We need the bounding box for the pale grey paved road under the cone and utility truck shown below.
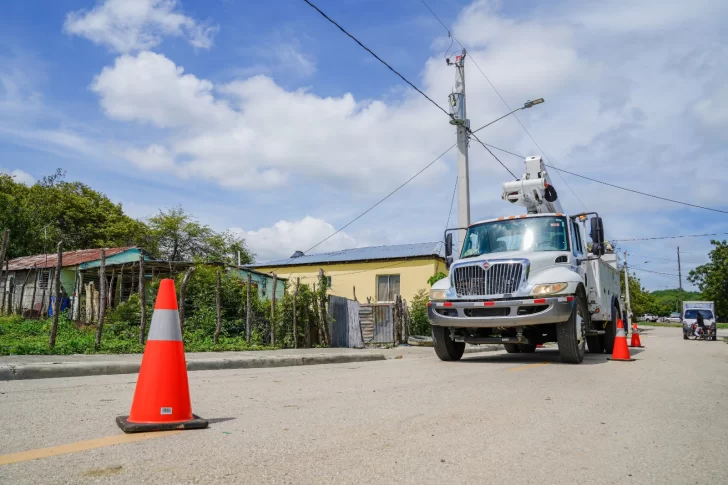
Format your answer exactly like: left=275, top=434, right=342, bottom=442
left=0, top=328, right=728, bottom=484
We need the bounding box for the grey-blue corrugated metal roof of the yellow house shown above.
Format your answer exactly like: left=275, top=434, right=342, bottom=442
left=248, top=241, right=445, bottom=268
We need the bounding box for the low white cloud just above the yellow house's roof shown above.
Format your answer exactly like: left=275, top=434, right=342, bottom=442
left=231, top=216, right=356, bottom=262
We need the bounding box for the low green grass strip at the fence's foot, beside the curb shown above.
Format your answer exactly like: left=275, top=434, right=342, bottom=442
left=0, top=316, right=273, bottom=355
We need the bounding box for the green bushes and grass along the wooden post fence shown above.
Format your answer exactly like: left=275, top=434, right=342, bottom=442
left=0, top=264, right=325, bottom=355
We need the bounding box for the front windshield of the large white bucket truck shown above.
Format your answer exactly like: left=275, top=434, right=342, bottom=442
left=460, top=216, right=569, bottom=258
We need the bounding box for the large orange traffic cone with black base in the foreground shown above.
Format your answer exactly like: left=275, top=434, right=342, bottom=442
left=116, top=279, right=207, bottom=433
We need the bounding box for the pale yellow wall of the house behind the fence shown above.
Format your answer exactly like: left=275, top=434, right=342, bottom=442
left=255, top=258, right=446, bottom=302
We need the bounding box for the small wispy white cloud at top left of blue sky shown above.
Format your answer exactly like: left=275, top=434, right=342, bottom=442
left=63, top=0, right=218, bottom=53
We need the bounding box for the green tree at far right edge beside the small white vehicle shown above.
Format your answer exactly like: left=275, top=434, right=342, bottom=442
left=688, top=240, right=728, bottom=318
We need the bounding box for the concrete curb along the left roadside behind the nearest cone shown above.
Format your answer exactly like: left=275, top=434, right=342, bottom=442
left=0, top=354, right=385, bottom=381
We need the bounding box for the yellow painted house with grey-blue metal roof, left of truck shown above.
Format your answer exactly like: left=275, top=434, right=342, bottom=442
left=249, top=242, right=447, bottom=302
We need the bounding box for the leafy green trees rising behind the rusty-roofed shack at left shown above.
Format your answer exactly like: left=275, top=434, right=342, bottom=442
left=0, top=169, right=252, bottom=263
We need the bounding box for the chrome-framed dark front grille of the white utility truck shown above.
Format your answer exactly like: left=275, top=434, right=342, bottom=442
left=453, top=262, right=523, bottom=297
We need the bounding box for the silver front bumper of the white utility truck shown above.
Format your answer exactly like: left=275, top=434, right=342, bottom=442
left=427, top=296, right=574, bottom=328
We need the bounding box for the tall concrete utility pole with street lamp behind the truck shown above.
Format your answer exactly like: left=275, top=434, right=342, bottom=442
left=447, top=49, right=470, bottom=255
